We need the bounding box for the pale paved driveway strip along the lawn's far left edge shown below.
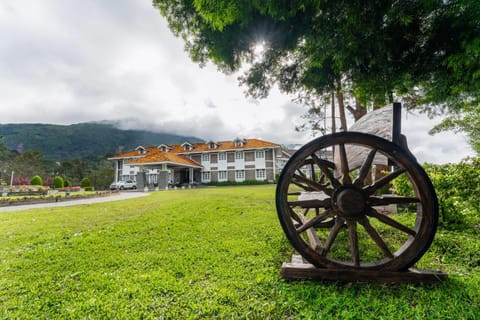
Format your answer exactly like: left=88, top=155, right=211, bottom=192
left=0, top=192, right=149, bottom=212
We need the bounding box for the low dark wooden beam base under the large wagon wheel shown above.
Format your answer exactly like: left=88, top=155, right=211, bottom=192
left=280, top=254, right=447, bottom=283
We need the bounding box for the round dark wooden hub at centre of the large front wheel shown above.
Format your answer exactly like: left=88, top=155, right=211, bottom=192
left=333, top=186, right=367, bottom=218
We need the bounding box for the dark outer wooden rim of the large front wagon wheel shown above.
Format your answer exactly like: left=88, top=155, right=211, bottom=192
left=276, top=132, right=438, bottom=271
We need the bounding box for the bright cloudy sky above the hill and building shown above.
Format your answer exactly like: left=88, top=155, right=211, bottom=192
left=0, top=0, right=473, bottom=163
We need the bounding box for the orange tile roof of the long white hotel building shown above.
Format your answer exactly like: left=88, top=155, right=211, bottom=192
left=109, top=139, right=280, bottom=167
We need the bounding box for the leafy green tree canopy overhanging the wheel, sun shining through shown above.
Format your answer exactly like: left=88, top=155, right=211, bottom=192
left=153, top=0, right=480, bottom=115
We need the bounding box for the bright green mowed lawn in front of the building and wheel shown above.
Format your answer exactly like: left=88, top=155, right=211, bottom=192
left=0, top=186, right=480, bottom=319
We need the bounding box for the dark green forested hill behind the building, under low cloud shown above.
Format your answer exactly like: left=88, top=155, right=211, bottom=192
left=0, top=122, right=203, bottom=161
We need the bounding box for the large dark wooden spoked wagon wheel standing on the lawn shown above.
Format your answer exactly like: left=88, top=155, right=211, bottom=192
left=276, top=132, right=438, bottom=271
